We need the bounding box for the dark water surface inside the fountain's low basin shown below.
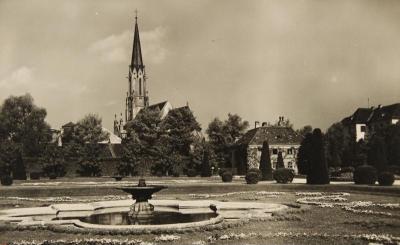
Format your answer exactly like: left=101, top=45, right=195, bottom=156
left=80, top=211, right=217, bottom=225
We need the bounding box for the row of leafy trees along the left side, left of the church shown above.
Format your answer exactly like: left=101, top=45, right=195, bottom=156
left=0, top=94, right=111, bottom=179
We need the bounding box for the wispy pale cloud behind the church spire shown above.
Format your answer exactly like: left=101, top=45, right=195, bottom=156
left=88, top=26, right=168, bottom=64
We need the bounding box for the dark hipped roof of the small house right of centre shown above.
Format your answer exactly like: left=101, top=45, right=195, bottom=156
left=236, top=126, right=303, bottom=145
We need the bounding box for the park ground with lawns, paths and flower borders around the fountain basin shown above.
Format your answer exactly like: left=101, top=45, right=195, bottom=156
left=0, top=177, right=400, bottom=245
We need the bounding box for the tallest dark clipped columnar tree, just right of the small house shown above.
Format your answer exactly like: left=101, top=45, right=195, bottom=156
left=307, top=128, right=329, bottom=185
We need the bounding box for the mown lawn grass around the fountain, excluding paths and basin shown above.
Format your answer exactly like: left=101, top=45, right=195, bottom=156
left=0, top=178, right=400, bottom=244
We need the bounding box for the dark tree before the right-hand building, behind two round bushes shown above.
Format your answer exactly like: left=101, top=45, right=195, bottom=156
left=368, top=135, right=388, bottom=172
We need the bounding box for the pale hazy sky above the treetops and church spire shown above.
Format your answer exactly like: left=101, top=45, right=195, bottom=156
left=0, top=0, right=400, bottom=132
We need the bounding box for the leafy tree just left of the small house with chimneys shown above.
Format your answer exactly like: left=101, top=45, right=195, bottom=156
left=206, top=113, right=249, bottom=168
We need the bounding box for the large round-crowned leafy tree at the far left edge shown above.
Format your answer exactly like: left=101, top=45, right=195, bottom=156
left=0, top=94, right=51, bottom=156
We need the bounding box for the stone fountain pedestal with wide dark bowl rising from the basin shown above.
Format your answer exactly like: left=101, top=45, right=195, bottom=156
left=118, top=179, right=167, bottom=225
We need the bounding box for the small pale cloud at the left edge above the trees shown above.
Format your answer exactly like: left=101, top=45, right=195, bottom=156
left=0, top=66, right=33, bottom=88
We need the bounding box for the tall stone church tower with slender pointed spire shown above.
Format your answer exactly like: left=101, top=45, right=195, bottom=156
left=125, top=15, right=149, bottom=122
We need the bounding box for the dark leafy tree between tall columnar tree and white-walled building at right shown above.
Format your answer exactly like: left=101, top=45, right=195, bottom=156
left=325, top=122, right=352, bottom=167
